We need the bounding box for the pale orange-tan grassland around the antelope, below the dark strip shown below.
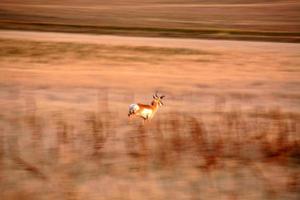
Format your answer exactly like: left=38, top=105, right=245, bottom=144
left=0, top=31, right=300, bottom=200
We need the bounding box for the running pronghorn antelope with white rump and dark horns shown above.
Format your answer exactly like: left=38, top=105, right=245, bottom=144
left=128, top=93, right=165, bottom=121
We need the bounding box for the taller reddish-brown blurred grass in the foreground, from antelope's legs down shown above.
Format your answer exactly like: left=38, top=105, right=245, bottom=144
left=0, top=96, right=300, bottom=199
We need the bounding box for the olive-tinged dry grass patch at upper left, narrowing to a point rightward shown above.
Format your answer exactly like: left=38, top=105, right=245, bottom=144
left=0, top=39, right=217, bottom=63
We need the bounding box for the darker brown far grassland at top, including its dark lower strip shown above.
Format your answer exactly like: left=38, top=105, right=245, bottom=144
left=0, top=0, right=300, bottom=42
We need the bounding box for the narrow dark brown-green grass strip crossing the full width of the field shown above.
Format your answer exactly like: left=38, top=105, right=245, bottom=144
left=0, top=21, right=300, bottom=43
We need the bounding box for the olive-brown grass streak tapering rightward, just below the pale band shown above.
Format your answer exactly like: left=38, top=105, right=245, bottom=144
left=0, top=39, right=213, bottom=59
